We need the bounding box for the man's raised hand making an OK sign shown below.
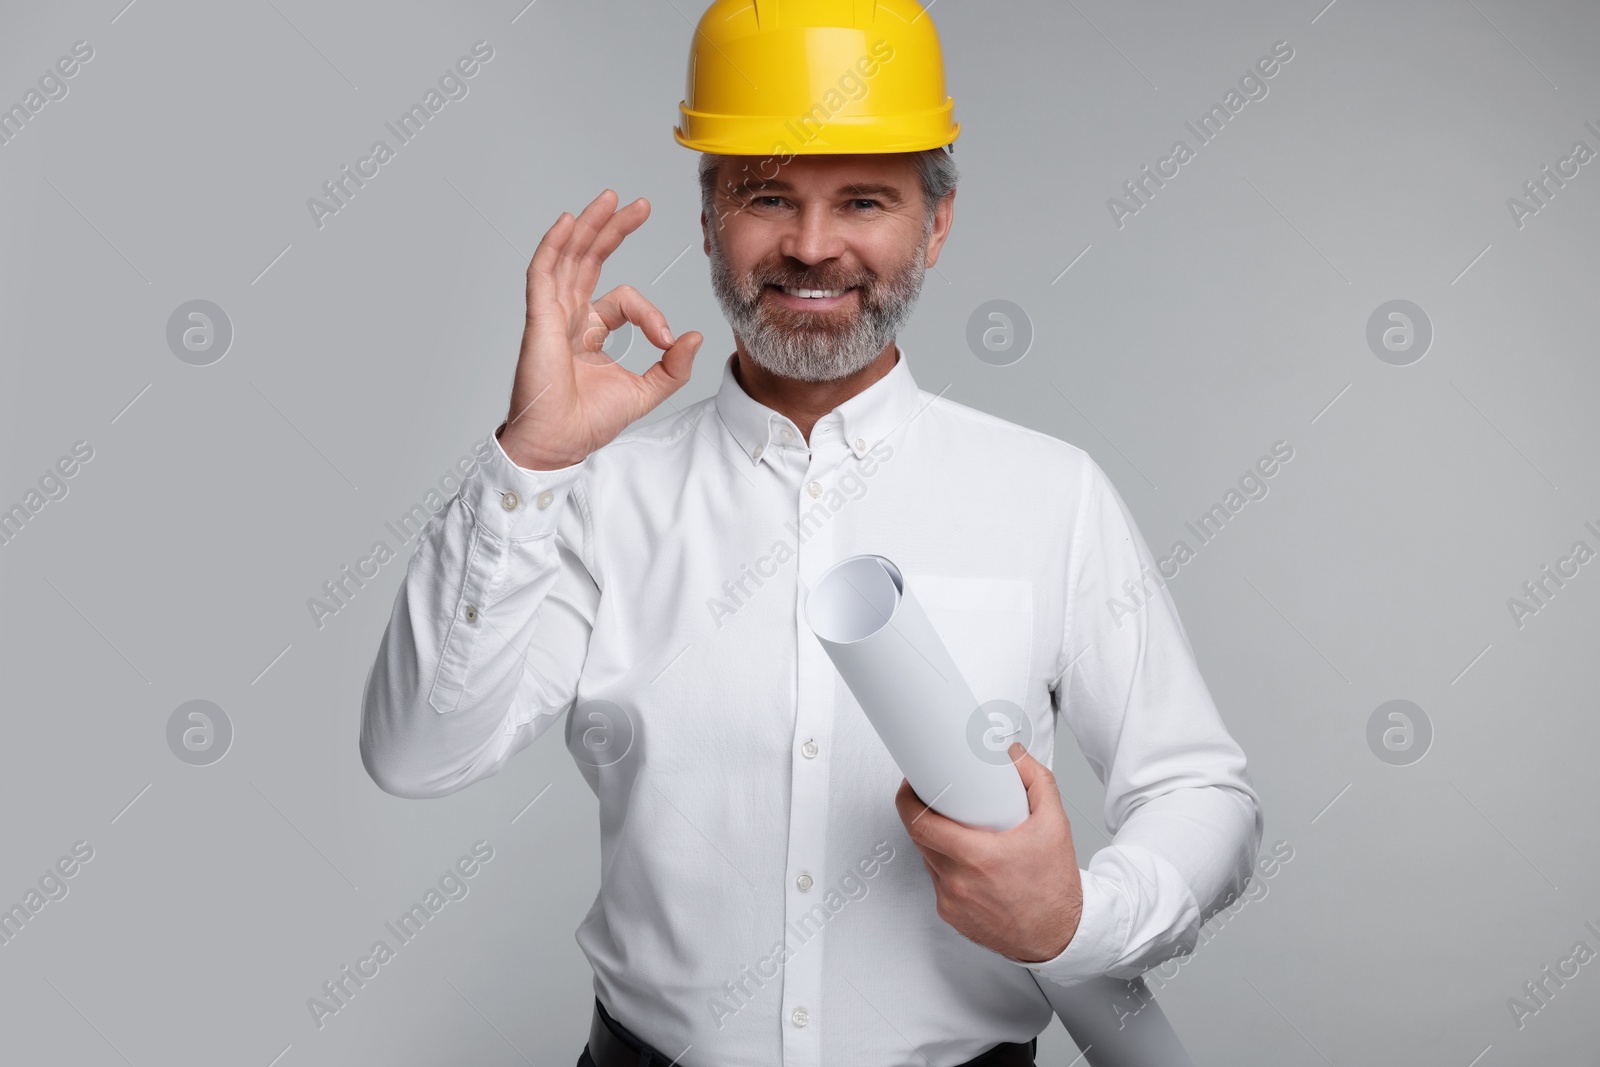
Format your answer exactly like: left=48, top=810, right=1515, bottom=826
left=499, top=189, right=704, bottom=470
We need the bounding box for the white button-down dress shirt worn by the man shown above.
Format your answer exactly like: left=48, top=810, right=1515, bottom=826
left=362, top=347, right=1262, bottom=1067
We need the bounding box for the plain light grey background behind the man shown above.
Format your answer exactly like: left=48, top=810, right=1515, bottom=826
left=0, top=0, right=1600, bottom=1067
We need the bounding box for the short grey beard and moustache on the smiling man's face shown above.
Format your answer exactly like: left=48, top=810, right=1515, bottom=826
left=709, top=219, right=933, bottom=382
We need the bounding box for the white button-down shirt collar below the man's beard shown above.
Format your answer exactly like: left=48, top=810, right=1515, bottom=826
left=717, top=342, right=918, bottom=464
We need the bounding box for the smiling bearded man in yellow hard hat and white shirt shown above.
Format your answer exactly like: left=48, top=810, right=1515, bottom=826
left=362, top=0, right=1262, bottom=1067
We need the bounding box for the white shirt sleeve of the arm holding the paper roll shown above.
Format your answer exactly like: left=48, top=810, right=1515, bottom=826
left=1008, top=456, right=1264, bottom=985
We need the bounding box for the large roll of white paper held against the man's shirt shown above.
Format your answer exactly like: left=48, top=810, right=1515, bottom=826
left=805, top=553, right=1194, bottom=1067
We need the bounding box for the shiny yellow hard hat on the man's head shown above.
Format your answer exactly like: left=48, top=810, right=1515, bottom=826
left=672, top=0, right=962, bottom=155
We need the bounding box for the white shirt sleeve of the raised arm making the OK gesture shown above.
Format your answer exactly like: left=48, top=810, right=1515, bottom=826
left=360, top=425, right=600, bottom=798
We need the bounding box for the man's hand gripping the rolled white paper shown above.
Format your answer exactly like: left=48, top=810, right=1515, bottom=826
left=894, top=741, right=1083, bottom=963
